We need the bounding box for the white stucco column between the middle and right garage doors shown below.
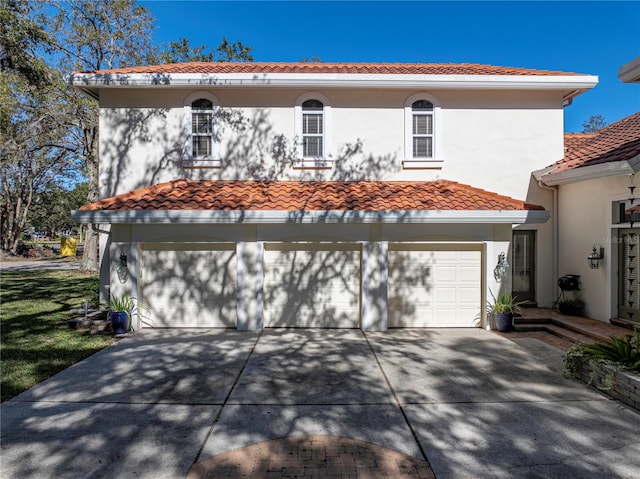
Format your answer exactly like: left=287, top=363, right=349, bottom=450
left=361, top=241, right=389, bottom=331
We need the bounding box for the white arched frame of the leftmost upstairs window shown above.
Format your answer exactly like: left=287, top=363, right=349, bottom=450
left=182, top=91, right=222, bottom=168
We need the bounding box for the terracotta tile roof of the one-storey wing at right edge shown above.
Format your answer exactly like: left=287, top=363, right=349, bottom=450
left=551, top=112, right=640, bottom=173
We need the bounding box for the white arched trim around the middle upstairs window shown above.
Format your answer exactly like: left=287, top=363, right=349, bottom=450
left=293, top=92, right=333, bottom=168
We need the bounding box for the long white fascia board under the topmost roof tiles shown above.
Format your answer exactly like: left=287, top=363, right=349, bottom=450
left=69, top=73, right=598, bottom=92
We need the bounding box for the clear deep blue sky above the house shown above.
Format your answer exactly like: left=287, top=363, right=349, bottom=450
left=140, top=0, right=640, bottom=131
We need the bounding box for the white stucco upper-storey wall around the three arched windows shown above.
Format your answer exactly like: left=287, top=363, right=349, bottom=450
left=100, top=88, right=563, bottom=199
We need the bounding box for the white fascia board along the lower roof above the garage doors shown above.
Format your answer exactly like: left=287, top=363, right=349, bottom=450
left=71, top=210, right=549, bottom=224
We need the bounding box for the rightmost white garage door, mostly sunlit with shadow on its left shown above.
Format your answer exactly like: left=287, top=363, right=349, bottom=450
left=388, top=245, right=482, bottom=327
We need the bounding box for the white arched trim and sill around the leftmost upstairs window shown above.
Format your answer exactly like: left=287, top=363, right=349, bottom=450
left=182, top=91, right=222, bottom=168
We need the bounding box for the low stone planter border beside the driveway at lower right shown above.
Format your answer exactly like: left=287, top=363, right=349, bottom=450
left=574, top=359, right=640, bottom=411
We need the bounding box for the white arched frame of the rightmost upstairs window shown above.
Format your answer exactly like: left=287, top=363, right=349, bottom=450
left=402, top=93, right=444, bottom=169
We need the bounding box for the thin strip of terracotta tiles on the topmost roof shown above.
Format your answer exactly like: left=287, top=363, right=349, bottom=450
left=83, top=62, right=578, bottom=76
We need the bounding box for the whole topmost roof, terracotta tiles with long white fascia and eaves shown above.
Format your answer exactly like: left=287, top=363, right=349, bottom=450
left=69, top=62, right=598, bottom=103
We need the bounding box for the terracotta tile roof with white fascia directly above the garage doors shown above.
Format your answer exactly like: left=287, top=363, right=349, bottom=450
left=73, top=179, right=548, bottom=227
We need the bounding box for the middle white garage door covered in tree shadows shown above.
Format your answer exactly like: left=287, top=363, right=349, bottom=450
left=264, top=243, right=360, bottom=328
